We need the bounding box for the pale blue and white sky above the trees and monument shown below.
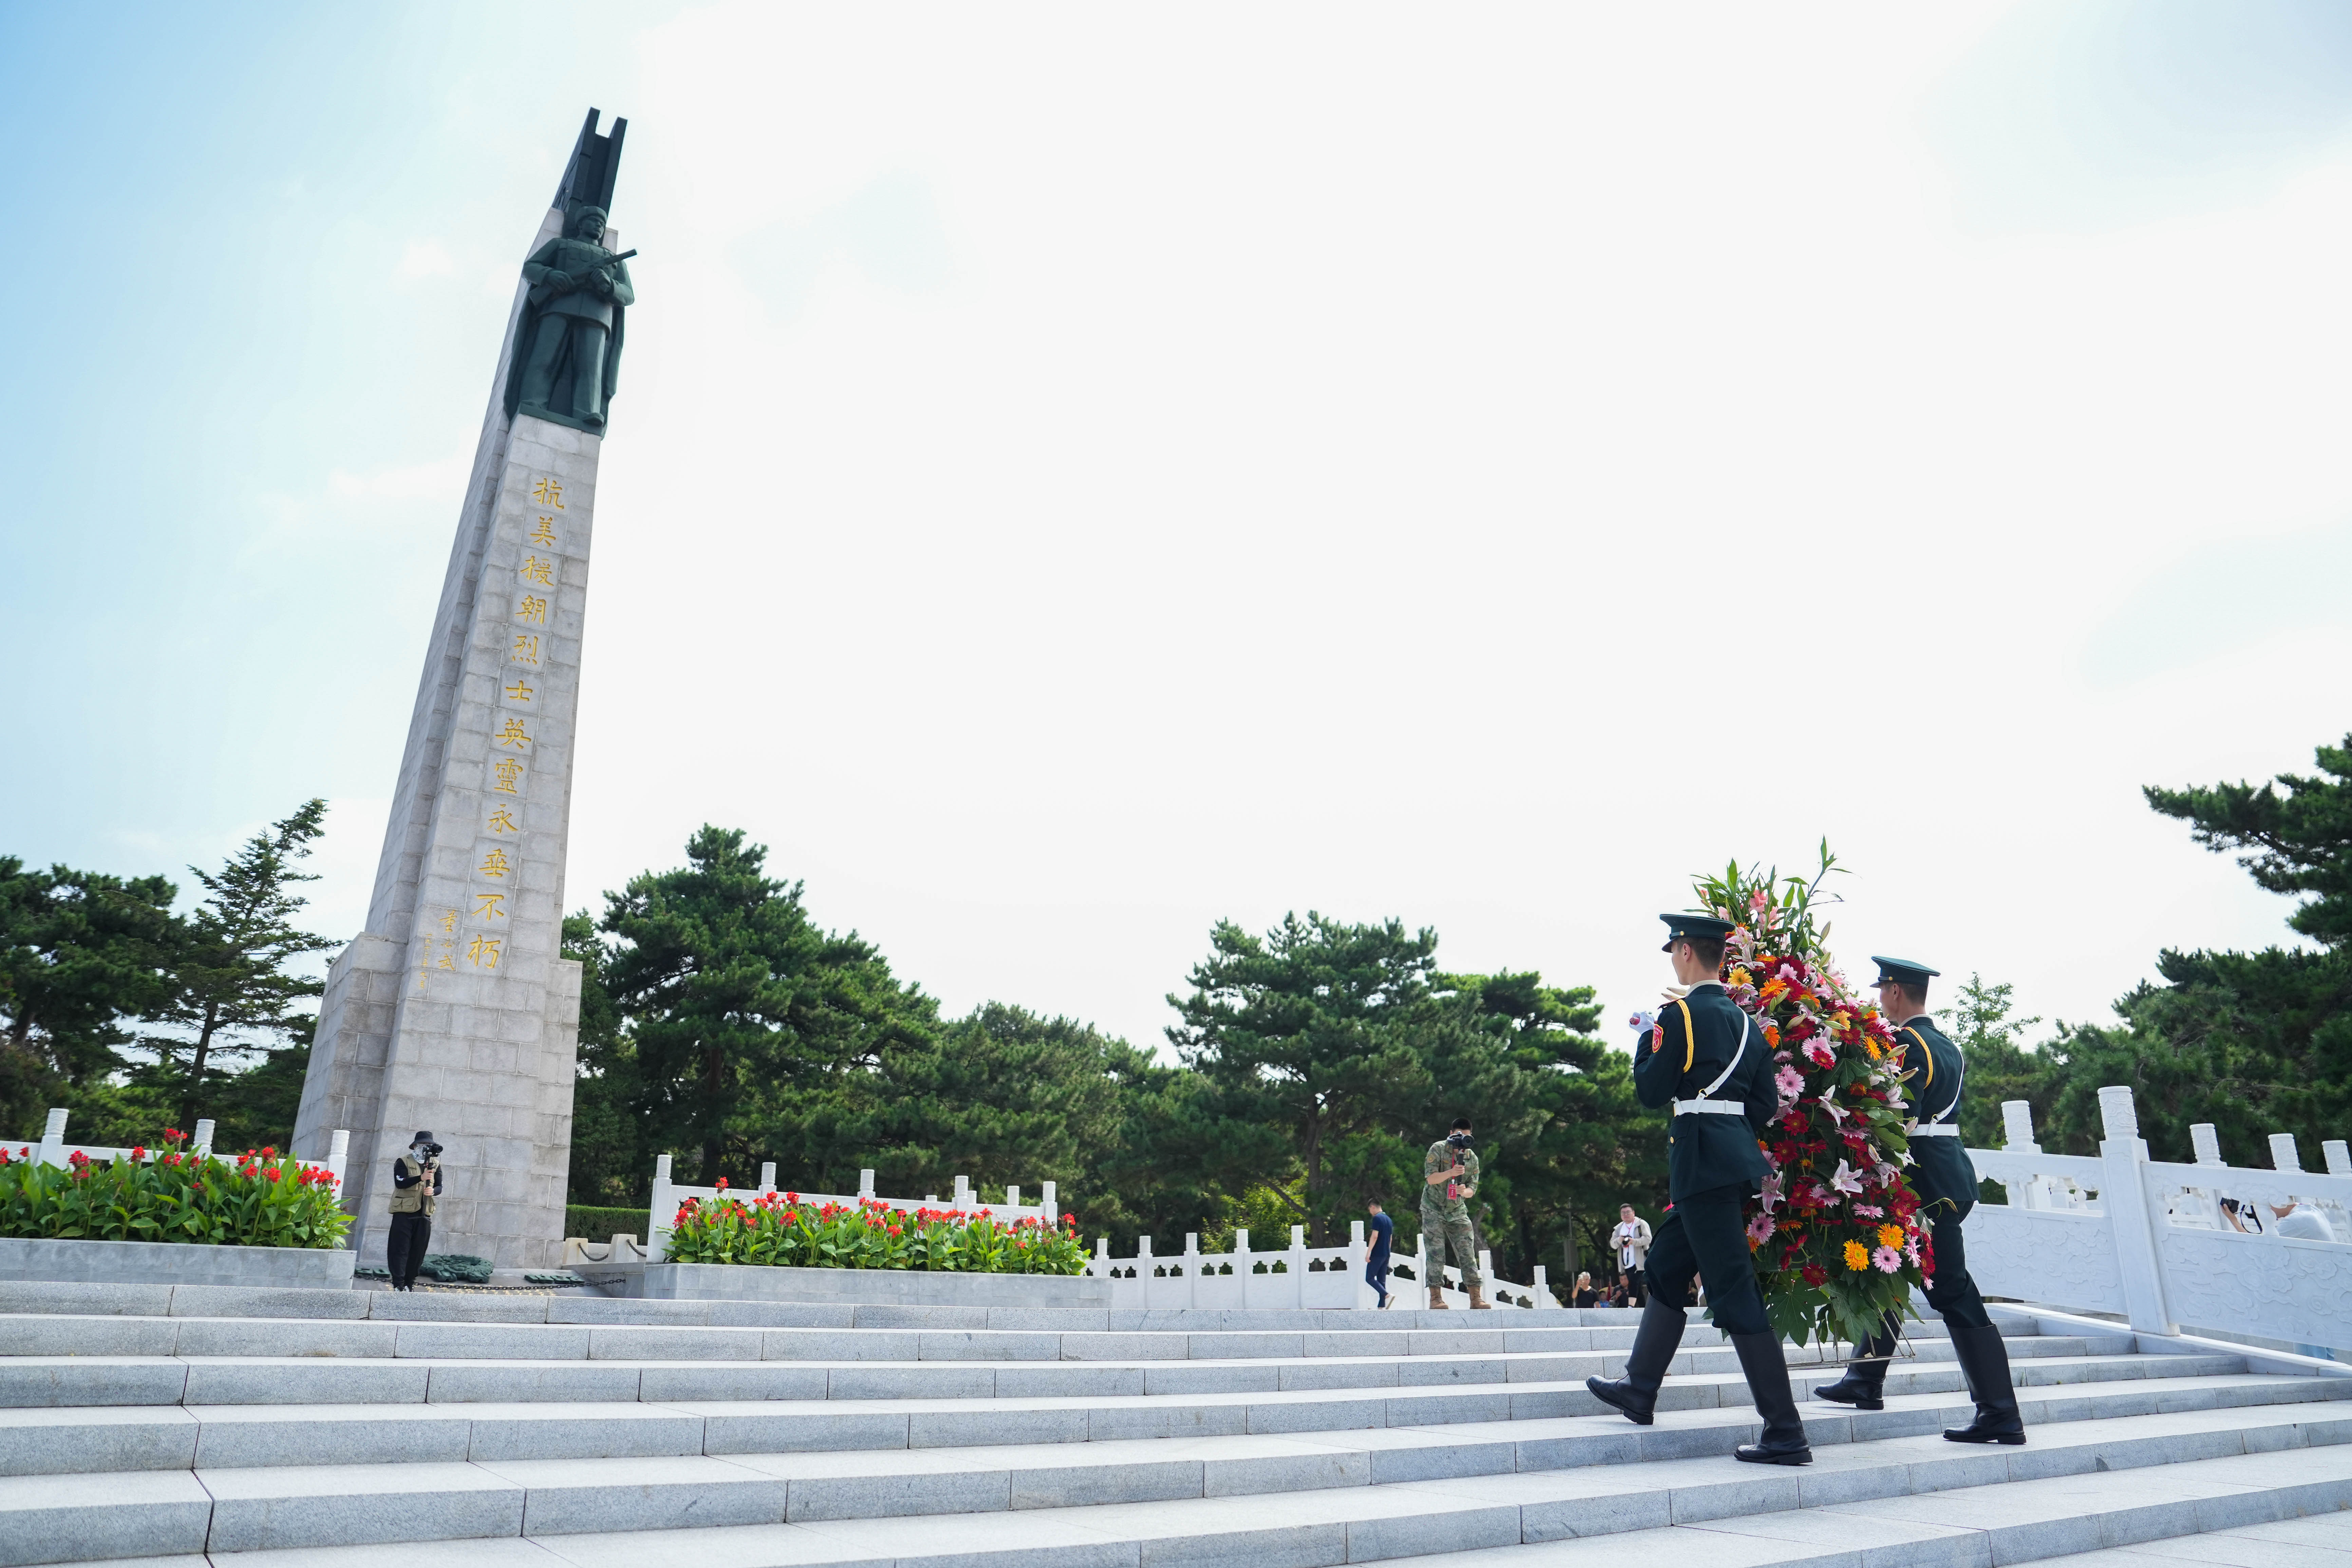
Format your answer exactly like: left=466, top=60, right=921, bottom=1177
left=0, top=0, right=2352, bottom=1072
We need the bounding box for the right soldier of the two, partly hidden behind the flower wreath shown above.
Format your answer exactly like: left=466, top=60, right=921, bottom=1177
left=1813, top=955, right=2025, bottom=1446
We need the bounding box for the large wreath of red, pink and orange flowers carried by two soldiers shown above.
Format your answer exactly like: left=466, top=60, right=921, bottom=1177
left=1696, top=842, right=1936, bottom=1345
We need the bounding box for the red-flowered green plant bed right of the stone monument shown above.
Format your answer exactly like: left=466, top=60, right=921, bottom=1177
left=668, top=1180, right=1087, bottom=1274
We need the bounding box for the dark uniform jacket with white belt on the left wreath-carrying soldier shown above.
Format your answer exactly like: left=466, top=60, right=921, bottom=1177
left=1632, top=985, right=1781, bottom=1204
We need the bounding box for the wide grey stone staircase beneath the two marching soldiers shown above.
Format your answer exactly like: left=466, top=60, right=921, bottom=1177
left=0, top=1284, right=2352, bottom=1568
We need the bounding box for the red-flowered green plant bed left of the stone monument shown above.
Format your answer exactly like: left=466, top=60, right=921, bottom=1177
left=0, top=1131, right=351, bottom=1248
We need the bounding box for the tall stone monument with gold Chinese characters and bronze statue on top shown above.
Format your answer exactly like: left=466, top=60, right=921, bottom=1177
left=294, top=111, right=635, bottom=1267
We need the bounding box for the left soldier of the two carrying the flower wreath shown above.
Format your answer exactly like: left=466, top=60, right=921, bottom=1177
left=1585, top=914, right=1813, bottom=1465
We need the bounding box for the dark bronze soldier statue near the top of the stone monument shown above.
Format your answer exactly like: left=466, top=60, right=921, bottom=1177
left=506, top=207, right=637, bottom=435
